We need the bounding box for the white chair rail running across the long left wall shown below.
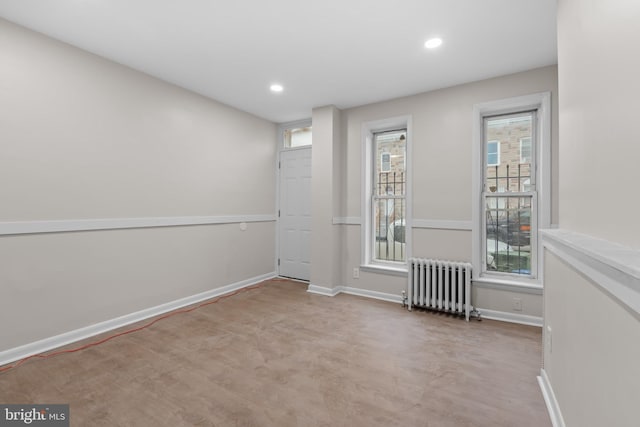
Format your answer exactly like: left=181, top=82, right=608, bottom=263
left=0, top=215, right=276, bottom=236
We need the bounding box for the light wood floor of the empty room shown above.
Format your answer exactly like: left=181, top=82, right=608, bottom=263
left=0, top=280, right=551, bottom=427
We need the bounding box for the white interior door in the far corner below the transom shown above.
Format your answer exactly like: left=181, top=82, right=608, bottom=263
left=278, top=148, right=311, bottom=280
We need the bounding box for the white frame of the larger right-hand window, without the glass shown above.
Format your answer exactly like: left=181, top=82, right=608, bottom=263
left=471, top=92, right=551, bottom=290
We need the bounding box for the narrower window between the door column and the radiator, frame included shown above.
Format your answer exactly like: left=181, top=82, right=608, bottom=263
left=360, top=116, right=411, bottom=275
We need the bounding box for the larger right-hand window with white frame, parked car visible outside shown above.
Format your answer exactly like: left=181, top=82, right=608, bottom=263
left=472, top=92, right=551, bottom=289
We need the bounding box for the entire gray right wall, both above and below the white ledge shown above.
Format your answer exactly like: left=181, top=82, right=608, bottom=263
left=544, top=0, right=640, bottom=427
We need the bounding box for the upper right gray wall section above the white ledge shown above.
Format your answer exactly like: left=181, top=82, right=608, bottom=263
left=558, top=0, right=640, bottom=249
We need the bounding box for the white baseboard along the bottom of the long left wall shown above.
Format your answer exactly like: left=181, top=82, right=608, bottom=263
left=0, top=272, right=277, bottom=366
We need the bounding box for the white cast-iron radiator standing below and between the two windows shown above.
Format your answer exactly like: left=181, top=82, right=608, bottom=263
left=407, top=258, right=473, bottom=321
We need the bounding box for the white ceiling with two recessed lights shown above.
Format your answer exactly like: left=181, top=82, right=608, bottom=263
left=0, top=0, right=557, bottom=122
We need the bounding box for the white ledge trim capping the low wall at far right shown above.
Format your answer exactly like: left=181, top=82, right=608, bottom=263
left=542, top=229, right=640, bottom=317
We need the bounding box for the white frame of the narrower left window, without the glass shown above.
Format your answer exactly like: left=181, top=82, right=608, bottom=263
left=360, top=116, right=413, bottom=276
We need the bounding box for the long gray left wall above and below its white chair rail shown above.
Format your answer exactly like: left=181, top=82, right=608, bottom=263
left=0, top=19, right=276, bottom=351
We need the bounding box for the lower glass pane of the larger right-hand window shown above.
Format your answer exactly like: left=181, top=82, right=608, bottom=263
left=485, top=196, right=532, bottom=275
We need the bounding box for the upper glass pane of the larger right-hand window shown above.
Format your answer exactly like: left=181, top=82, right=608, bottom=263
left=485, top=112, right=534, bottom=193
